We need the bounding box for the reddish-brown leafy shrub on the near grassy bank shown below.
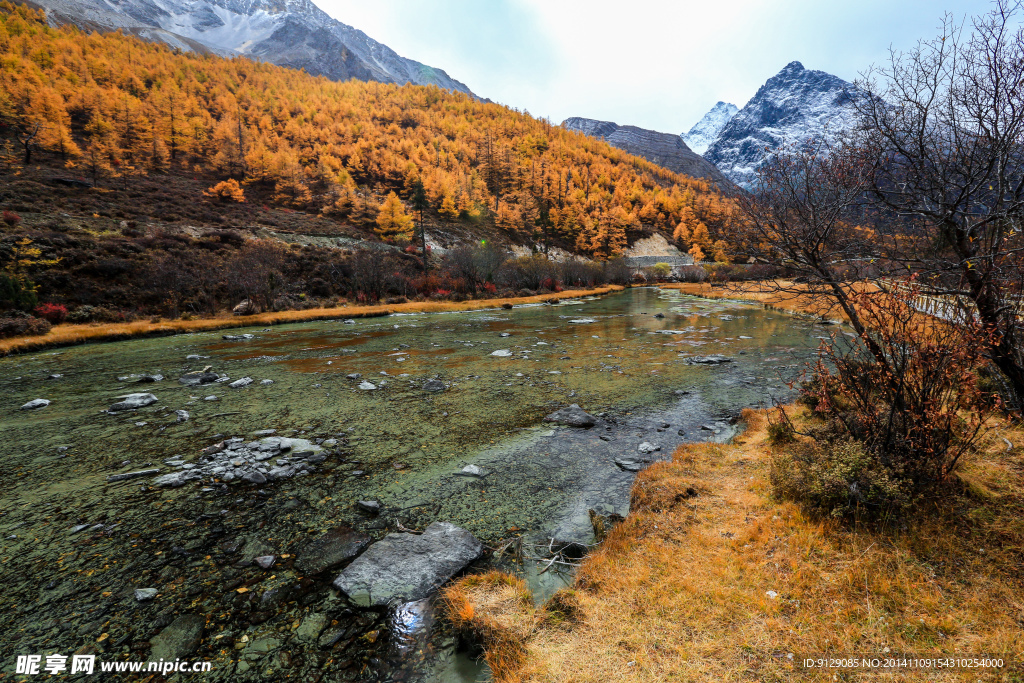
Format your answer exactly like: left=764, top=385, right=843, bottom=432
left=781, top=288, right=990, bottom=514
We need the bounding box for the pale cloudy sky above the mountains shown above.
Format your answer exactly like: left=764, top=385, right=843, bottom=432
left=315, top=0, right=991, bottom=133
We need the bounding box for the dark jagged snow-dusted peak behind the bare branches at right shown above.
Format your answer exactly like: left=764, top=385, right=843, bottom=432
left=703, top=61, right=863, bottom=188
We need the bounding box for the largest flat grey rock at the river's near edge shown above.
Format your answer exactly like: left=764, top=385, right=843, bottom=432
left=334, top=522, right=483, bottom=607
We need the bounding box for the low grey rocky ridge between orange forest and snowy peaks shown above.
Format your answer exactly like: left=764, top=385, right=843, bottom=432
left=562, top=117, right=736, bottom=194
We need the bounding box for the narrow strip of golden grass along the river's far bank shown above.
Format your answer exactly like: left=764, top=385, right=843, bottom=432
left=0, top=285, right=625, bottom=355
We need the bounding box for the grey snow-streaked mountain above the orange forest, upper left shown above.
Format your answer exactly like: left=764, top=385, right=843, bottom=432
left=33, top=0, right=472, bottom=94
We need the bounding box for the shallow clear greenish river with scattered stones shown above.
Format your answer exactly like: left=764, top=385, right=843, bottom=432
left=0, top=289, right=828, bottom=681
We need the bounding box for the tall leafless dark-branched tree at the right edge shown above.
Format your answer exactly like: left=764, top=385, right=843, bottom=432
left=855, top=0, right=1024, bottom=396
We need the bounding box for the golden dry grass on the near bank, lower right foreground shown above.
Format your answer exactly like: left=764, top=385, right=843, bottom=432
left=454, top=409, right=1024, bottom=683
